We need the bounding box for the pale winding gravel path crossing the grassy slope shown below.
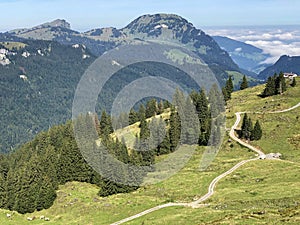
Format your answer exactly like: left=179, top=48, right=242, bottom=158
left=111, top=102, right=300, bottom=225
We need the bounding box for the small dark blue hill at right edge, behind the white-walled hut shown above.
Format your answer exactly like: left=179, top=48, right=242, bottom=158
left=258, top=55, right=300, bottom=79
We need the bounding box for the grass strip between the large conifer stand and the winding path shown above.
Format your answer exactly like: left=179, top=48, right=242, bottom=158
left=0, top=140, right=253, bottom=224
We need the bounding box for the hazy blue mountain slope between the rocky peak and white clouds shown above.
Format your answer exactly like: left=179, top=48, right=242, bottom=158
left=213, top=36, right=270, bottom=74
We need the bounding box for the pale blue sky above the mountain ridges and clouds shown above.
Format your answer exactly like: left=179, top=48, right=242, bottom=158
left=0, top=0, right=300, bottom=32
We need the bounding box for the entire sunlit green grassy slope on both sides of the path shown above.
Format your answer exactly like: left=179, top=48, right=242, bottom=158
left=0, top=79, right=300, bottom=224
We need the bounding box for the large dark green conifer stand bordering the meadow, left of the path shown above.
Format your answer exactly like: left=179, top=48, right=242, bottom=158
left=0, top=85, right=224, bottom=213
